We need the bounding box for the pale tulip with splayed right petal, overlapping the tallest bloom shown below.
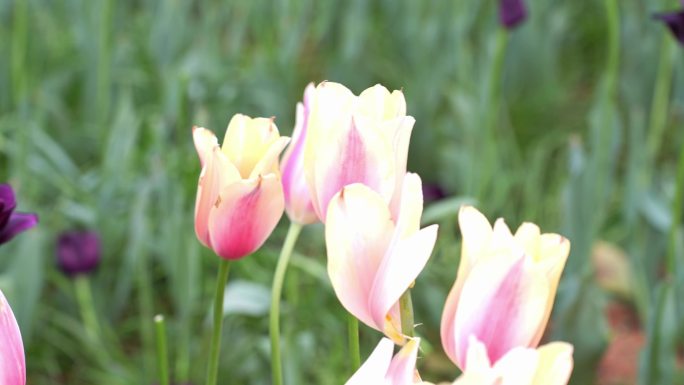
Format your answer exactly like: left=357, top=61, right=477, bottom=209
left=325, top=173, right=437, bottom=344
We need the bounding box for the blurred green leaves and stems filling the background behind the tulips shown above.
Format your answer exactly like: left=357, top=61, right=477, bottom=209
left=0, top=0, right=684, bottom=385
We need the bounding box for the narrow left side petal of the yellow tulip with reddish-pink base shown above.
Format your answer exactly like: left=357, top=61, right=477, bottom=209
left=195, top=146, right=240, bottom=247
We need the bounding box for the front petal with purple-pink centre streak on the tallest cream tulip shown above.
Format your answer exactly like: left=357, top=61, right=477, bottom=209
left=312, top=116, right=395, bottom=219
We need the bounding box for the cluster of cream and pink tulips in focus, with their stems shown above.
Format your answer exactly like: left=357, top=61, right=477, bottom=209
left=193, top=82, right=573, bottom=385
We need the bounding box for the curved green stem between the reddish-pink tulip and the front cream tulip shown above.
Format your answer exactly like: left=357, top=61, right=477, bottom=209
left=269, top=222, right=302, bottom=385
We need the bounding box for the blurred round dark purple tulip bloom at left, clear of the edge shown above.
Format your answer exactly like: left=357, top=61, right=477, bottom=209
left=57, top=231, right=100, bottom=276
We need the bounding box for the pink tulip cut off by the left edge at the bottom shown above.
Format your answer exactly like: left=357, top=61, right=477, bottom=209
left=0, top=291, right=26, bottom=385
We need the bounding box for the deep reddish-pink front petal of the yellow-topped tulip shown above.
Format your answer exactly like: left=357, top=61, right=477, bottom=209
left=209, top=174, right=285, bottom=259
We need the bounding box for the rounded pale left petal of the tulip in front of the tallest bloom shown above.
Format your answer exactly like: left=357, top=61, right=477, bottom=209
left=325, top=184, right=394, bottom=330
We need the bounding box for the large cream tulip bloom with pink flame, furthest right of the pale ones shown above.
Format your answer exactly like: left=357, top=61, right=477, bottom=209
left=441, top=206, right=570, bottom=369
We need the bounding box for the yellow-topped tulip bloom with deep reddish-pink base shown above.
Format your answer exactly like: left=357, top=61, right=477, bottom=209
left=193, top=114, right=289, bottom=259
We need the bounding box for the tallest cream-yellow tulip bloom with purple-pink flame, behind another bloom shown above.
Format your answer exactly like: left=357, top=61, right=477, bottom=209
left=304, top=82, right=415, bottom=222
